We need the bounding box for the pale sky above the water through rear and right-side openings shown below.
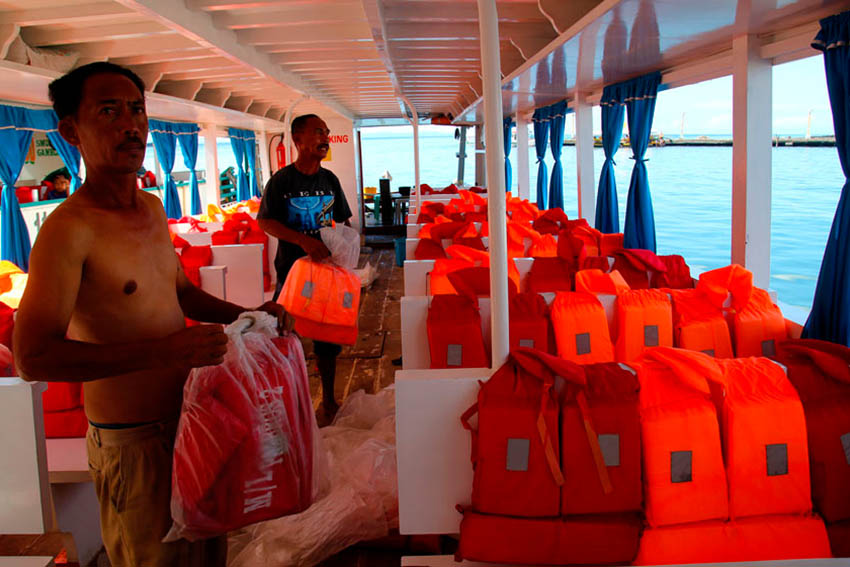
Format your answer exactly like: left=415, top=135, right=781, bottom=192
left=364, top=54, right=833, bottom=138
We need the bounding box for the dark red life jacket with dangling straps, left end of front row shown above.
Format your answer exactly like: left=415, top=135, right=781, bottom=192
left=458, top=348, right=641, bottom=565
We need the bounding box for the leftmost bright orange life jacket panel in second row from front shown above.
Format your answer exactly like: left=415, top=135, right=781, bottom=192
left=552, top=291, right=614, bottom=364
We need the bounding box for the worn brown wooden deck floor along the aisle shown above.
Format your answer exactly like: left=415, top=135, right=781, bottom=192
left=0, top=248, right=438, bottom=567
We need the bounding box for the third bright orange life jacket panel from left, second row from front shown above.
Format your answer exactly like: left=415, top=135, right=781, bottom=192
left=670, top=289, right=735, bottom=358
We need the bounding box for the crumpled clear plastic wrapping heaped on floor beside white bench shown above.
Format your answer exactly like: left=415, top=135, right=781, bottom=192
left=228, top=388, right=398, bottom=567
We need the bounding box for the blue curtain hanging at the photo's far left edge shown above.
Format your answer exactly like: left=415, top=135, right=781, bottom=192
left=0, top=106, right=32, bottom=272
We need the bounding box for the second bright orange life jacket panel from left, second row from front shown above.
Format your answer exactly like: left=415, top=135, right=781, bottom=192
left=615, top=289, right=673, bottom=362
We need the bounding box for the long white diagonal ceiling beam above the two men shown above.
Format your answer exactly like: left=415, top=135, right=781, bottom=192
left=116, top=0, right=354, bottom=118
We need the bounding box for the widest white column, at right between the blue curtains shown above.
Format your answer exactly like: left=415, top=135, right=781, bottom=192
left=732, top=35, right=773, bottom=289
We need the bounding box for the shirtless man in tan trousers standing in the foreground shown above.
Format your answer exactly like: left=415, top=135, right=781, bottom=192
left=14, top=63, right=281, bottom=567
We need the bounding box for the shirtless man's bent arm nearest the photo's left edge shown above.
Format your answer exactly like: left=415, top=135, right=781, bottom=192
left=14, top=210, right=227, bottom=382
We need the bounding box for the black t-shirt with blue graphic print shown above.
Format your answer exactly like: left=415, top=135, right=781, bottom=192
left=257, top=164, right=351, bottom=282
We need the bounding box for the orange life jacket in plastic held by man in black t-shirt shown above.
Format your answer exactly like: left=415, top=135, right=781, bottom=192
left=278, top=257, right=360, bottom=345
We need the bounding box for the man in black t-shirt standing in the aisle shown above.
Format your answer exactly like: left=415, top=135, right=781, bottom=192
left=257, top=114, right=351, bottom=417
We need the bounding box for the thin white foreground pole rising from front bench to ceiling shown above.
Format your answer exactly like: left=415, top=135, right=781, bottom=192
left=478, top=0, right=510, bottom=368
